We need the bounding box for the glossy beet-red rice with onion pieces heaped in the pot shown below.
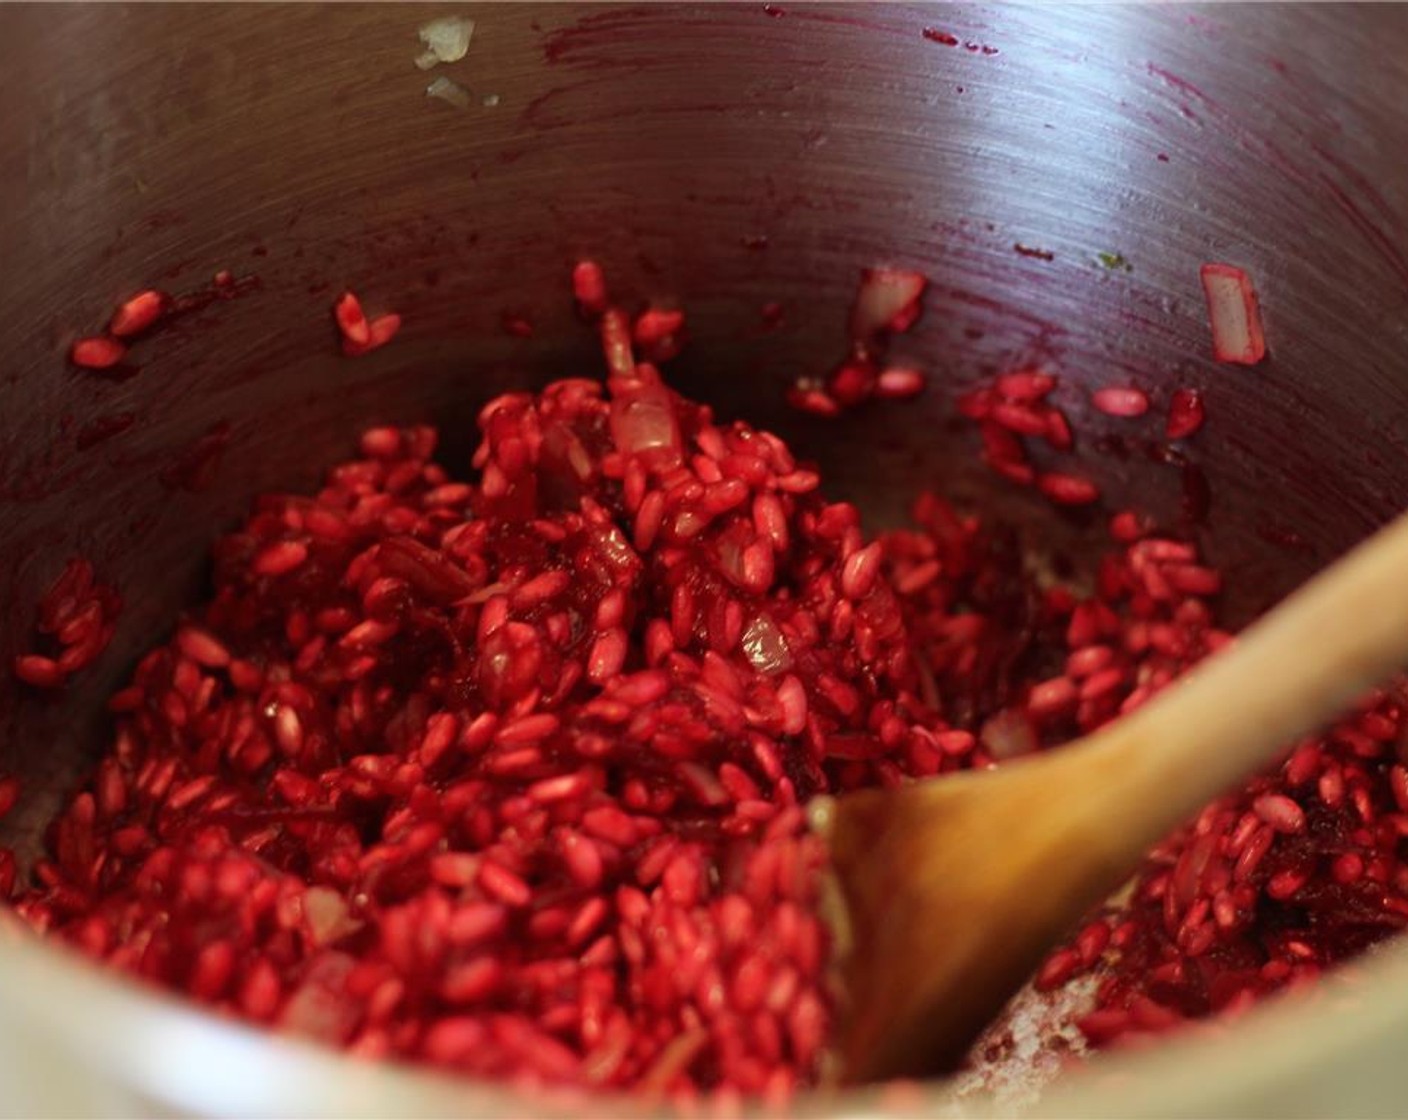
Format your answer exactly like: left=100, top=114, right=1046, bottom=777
left=0, top=263, right=1408, bottom=1097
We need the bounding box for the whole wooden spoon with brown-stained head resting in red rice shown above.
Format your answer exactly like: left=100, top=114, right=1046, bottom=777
left=811, top=514, right=1408, bottom=1082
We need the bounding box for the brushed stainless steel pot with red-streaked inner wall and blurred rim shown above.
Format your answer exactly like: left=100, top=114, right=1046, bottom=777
left=0, top=0, right=1408, bottom=1116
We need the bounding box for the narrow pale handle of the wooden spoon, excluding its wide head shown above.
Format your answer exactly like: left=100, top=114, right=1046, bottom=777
left=1070, top=514, right=1408, bottom=845
